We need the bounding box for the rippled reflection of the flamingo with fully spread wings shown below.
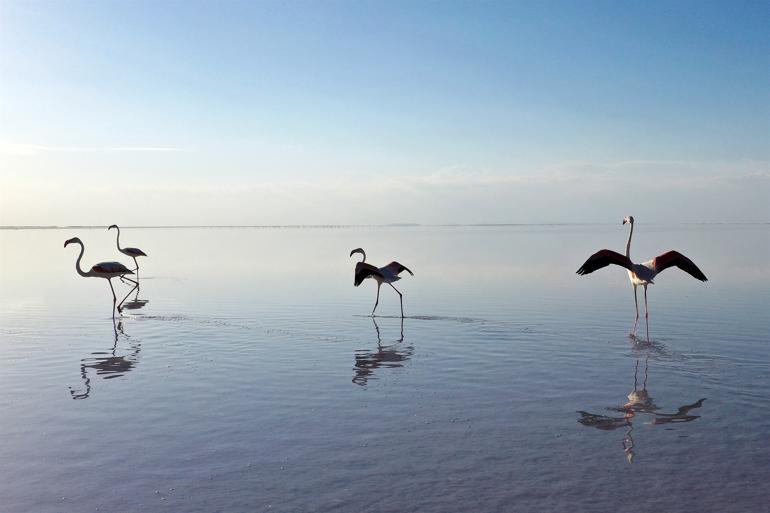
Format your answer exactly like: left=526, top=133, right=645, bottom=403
left=577, top=343, right=706, bottom=463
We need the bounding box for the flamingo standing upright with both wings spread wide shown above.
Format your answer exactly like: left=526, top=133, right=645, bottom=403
left=577, top=216, right=708, bottom=342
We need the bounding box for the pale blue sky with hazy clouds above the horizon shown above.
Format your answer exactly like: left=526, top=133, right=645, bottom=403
left=0, top=0, right=770, bottom=225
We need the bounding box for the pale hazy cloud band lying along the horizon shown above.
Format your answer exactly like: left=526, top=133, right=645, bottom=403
left=0, top=161, right=770, bottom=224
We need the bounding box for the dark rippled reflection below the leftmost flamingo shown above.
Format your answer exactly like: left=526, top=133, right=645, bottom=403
left=70, top=320, right=142, bottom=399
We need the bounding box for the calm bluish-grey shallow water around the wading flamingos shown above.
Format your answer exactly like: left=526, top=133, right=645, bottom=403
left=0, top=222, right=770, bottom=513
